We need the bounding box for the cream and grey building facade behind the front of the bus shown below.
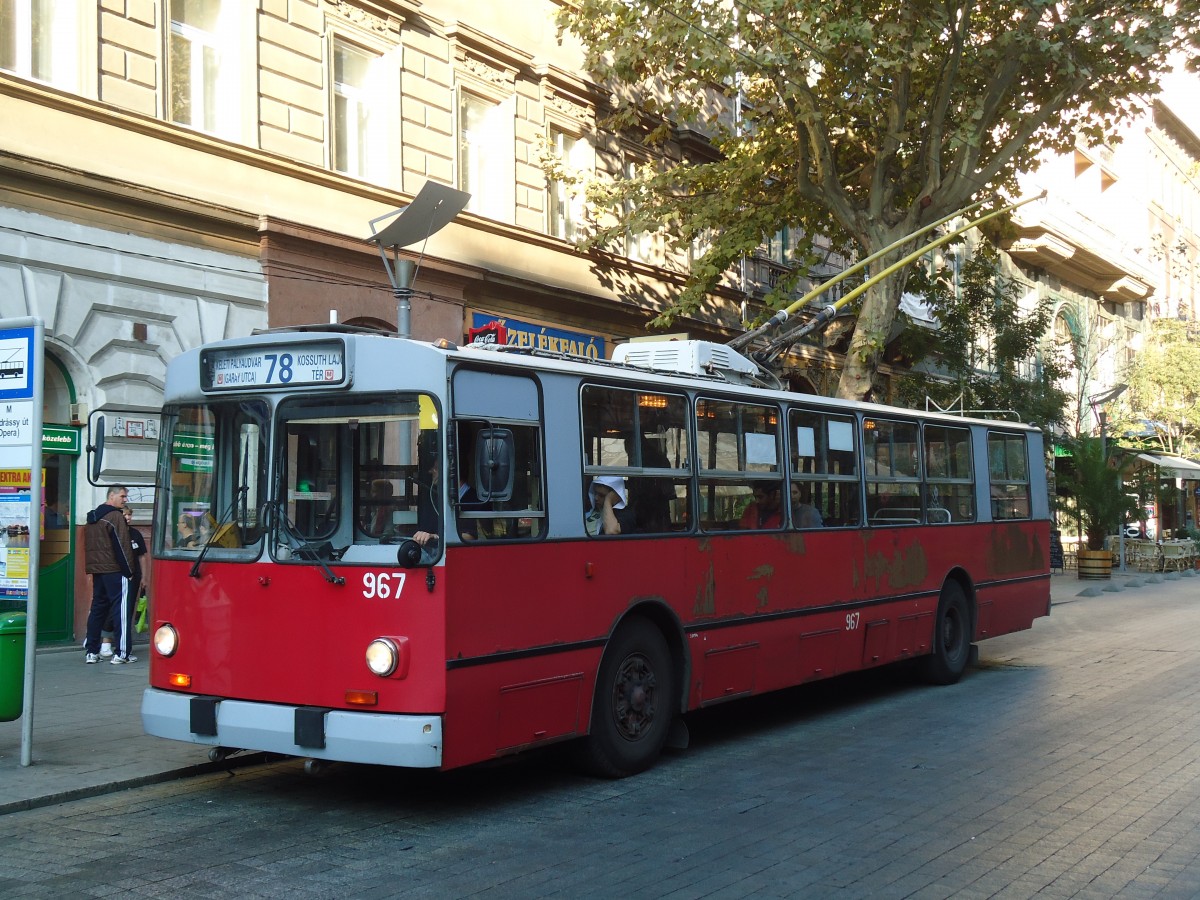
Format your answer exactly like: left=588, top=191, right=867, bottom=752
left=0, top=0, right=738, bottom=640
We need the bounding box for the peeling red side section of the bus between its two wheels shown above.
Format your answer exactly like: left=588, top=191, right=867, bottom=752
left=689, top=529, right=941, bottom=707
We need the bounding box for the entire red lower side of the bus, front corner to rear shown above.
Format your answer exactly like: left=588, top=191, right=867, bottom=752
left=444, top=522, right=1049, bottom=766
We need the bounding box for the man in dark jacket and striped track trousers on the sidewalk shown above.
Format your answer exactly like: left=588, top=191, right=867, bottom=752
left=83, top=485, right=137, bottom=666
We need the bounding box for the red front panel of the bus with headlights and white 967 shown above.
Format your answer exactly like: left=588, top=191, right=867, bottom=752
left=150, top=559, right=445, bottom=713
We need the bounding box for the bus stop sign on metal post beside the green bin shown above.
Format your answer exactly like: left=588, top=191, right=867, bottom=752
left=0, top=318, right=46, bottom=766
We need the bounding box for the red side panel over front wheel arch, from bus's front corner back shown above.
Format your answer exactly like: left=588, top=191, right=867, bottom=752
left=443, top=539, right=688, bottom=768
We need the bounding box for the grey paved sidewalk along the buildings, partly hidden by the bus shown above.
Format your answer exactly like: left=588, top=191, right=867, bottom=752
left=0, top=570, right=1200, bottom=815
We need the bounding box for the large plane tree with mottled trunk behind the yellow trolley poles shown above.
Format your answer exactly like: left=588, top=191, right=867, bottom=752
left=558, top=0, right=1200, bottom=398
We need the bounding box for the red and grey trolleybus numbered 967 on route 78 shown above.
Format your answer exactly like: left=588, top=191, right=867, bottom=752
left=142, top=326, right=1050, bottom=776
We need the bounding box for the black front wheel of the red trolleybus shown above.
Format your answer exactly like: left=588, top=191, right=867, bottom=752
left=580, top=619, right=677, bottom=778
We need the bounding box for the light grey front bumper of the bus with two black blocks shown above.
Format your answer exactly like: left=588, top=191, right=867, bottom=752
left=142, top=688, right=442, bottom=769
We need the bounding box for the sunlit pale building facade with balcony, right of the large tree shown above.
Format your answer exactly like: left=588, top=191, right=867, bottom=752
left=1007, top=64, right=1200, bottom=542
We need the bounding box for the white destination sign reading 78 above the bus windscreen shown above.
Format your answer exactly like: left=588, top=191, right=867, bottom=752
left=200, top=341, right=346, bottom=391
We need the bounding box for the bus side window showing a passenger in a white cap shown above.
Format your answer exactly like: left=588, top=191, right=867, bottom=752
left=581, top=385, right=691, bottom=536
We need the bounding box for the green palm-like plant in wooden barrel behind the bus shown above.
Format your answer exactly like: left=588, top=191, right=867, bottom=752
left=1058, top=437, right=1142, bottom=578
